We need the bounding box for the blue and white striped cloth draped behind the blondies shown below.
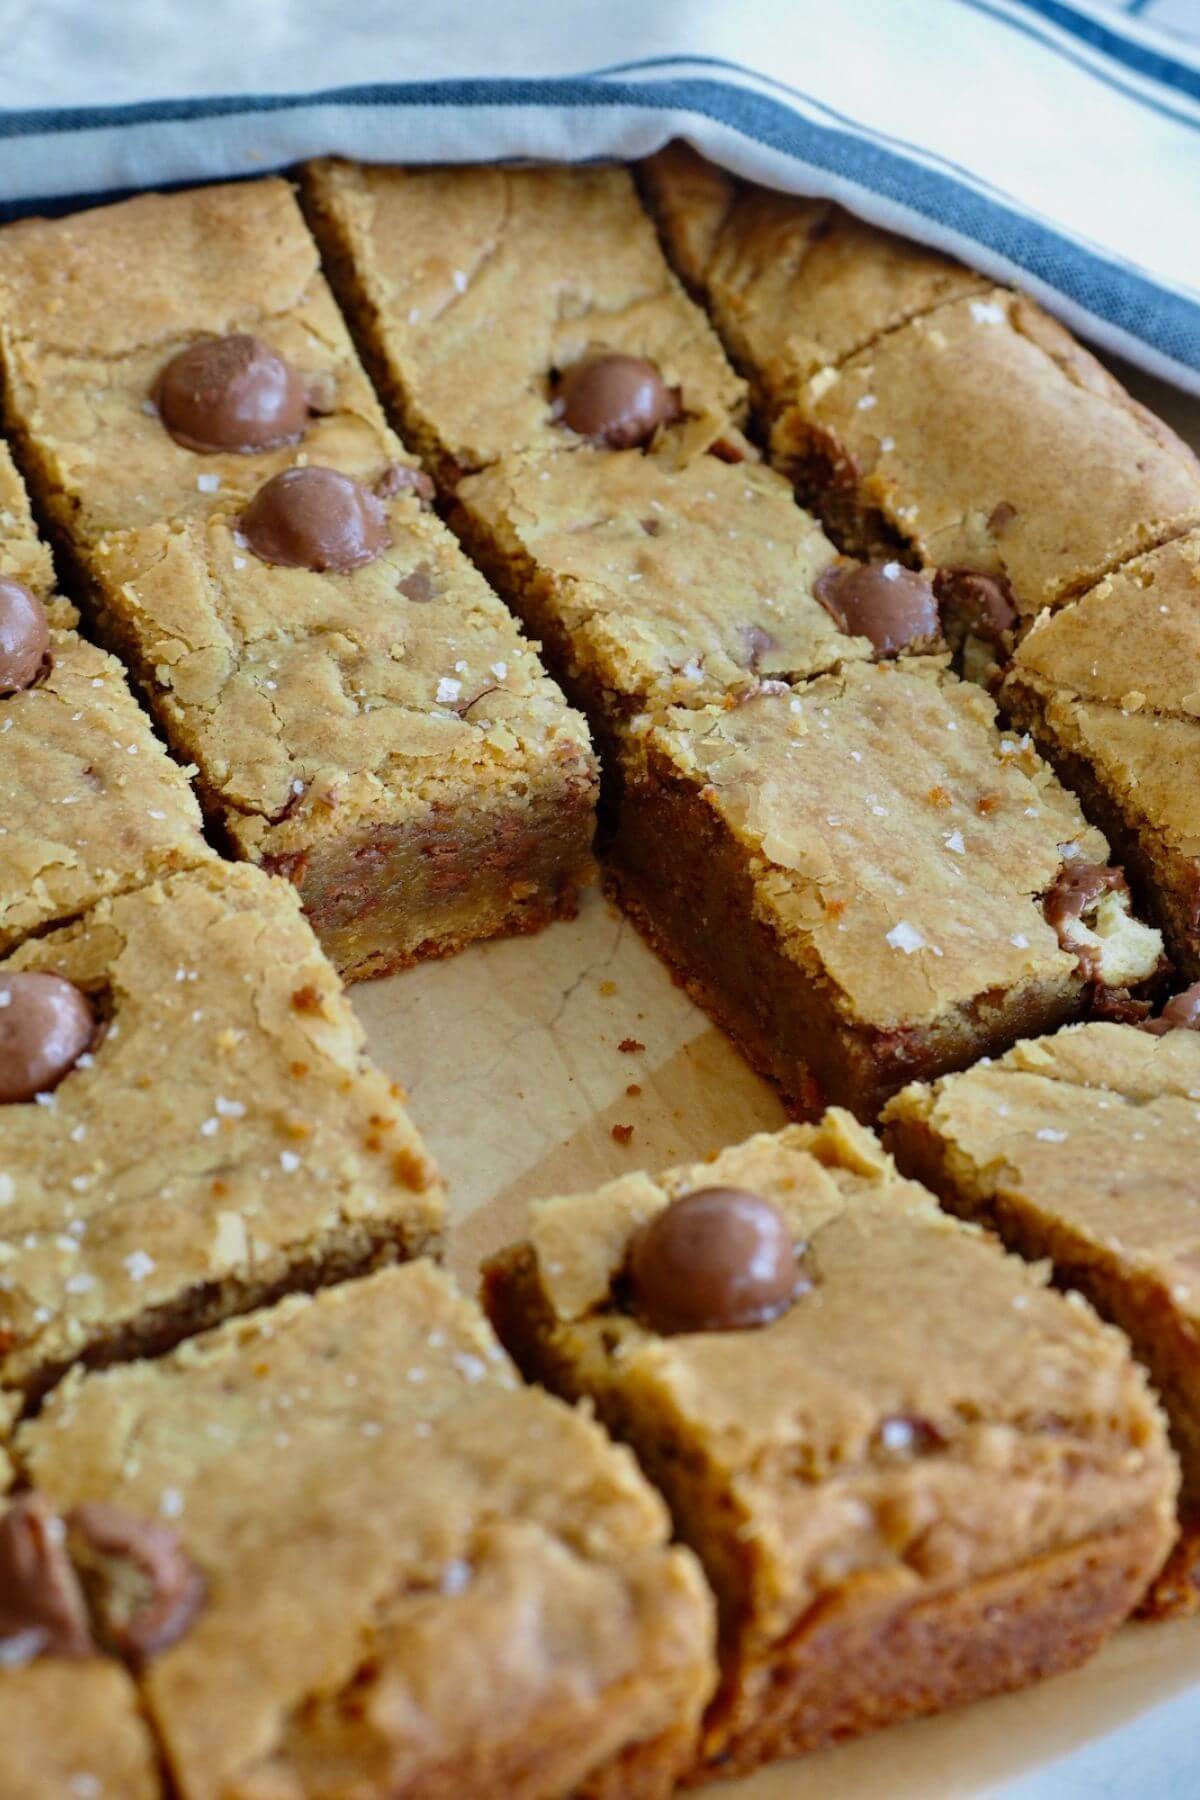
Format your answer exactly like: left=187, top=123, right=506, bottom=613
left=0, top=0, right=1200, bottom=394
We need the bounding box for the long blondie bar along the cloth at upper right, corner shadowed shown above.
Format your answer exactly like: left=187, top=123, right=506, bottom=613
left=646, top=148, right=1200, bottom=630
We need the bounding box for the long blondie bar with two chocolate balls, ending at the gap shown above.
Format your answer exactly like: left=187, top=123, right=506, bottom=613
left=0, top=180, right=596, bottom=979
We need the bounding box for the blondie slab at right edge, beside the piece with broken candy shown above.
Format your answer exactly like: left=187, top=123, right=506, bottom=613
left=1002, top=531, right=1200, bottom=979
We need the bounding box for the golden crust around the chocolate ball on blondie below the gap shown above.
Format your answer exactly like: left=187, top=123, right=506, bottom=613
left=489, top=1112, right=1177, bottom=1753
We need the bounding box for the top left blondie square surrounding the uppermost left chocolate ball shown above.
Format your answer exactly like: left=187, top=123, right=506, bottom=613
left=0, top=178, right=405, bottom=554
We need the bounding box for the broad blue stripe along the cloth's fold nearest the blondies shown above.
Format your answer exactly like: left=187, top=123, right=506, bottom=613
left=0, top=77, right=1200, bottom=371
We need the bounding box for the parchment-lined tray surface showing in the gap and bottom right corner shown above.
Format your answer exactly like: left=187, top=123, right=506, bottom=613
left=351, top=358, right=1200, bottom=1800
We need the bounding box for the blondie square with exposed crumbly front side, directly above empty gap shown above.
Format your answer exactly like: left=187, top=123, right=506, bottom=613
left=92, top=491, right=597, bottom=979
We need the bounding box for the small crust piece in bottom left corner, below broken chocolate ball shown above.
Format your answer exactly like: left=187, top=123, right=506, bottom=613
left=0, top=1656, right=162, bottom=1800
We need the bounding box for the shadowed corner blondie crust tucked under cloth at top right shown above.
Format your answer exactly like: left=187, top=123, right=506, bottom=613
left=640, top=140, right=988, bottom=401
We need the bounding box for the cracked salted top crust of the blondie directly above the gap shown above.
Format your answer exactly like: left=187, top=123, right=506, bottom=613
left=92, top=495, right=594, bottom=857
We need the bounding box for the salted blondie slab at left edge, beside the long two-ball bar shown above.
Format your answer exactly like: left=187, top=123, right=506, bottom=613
left=0, top=445, right=212, bottom=950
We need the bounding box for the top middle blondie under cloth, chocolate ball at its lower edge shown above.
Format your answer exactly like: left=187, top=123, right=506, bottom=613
left=302, top=160, right=745, bottom=488
